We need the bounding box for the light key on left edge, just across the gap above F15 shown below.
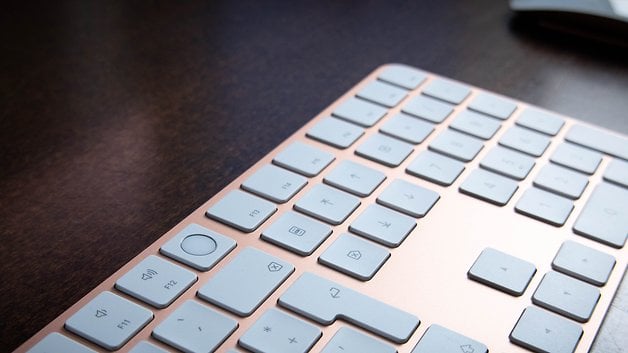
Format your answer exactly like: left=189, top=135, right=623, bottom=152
left=306, top=117, right=364, bottom=149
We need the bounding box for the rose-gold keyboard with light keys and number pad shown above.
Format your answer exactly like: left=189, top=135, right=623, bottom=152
left=17, top=64, right=628, bottom=353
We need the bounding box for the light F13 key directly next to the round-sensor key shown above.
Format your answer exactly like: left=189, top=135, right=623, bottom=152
left=205, top=190, right=277, bottom=233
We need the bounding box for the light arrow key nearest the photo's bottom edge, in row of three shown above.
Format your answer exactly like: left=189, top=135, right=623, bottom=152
left=510, top=306, right=582, bottom=353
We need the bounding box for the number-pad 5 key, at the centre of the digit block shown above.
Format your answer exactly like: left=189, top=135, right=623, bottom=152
left=480, top=146, right=535, bottom=180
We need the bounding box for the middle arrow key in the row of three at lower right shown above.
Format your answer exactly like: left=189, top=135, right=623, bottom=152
left=532, top=271, right=600, bottom=322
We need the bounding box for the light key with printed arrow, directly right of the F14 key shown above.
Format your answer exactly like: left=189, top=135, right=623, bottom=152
left=294, top=184, right=360, bottom=225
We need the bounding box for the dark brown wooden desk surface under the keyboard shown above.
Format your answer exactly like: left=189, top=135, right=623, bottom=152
left=0, top=0, right=628, bottom=352
